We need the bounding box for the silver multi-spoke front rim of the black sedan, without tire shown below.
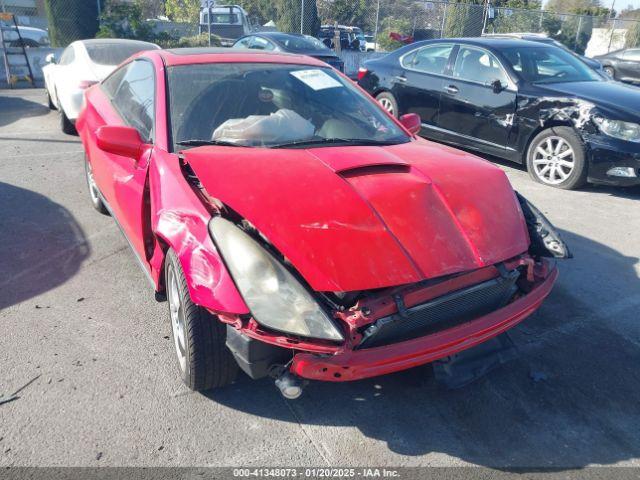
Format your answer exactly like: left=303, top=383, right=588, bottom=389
left=533, top=136, right=575, bottom=185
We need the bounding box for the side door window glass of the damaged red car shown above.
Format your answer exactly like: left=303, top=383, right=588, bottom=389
left=112, top=60, right=155, bottom=141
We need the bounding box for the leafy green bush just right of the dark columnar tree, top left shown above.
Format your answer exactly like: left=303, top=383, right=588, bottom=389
left=95, top=0, right=155, bottom=42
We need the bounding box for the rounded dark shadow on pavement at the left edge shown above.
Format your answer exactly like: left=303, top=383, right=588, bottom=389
left=0, top=182, right=90, bottom=310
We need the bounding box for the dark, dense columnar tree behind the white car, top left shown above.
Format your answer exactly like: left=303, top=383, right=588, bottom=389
left=45, top=0, right=98, bottom=47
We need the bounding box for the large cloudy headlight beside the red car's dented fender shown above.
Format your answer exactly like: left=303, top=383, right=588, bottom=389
left=209, top=217, right=344, bottom=341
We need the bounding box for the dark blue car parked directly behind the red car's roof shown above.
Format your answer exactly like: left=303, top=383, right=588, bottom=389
left=233, top=32, right=344, bottom=72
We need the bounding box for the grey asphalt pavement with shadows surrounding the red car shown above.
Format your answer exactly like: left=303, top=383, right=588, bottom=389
left=0, top=89, right=640, bottom=470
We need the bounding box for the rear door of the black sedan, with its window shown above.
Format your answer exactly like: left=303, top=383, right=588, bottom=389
left=394, top=43, right=454, bottom=126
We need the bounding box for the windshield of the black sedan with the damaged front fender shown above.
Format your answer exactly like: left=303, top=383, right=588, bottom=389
left=502, top=45, right=602, bottom=83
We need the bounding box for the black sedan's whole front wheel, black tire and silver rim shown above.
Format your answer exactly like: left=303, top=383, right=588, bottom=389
left=526, top=127, right=587, bottom=190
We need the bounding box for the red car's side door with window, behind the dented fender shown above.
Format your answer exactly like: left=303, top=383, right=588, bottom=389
left=90, top=59, right=156, bottom=266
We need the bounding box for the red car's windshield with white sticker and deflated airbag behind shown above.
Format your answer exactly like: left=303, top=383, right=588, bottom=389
left=168, top=63, right=409, bottom=150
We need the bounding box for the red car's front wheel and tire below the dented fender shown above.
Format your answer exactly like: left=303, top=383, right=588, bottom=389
left=164, top=249, right=238, bottom=391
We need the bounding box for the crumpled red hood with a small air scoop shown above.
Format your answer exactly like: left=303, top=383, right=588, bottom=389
left=183, top=140, right=529, bottom=291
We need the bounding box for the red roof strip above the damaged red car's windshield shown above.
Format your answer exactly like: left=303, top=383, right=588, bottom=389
left=152, top=47, right=327, bottom=67
